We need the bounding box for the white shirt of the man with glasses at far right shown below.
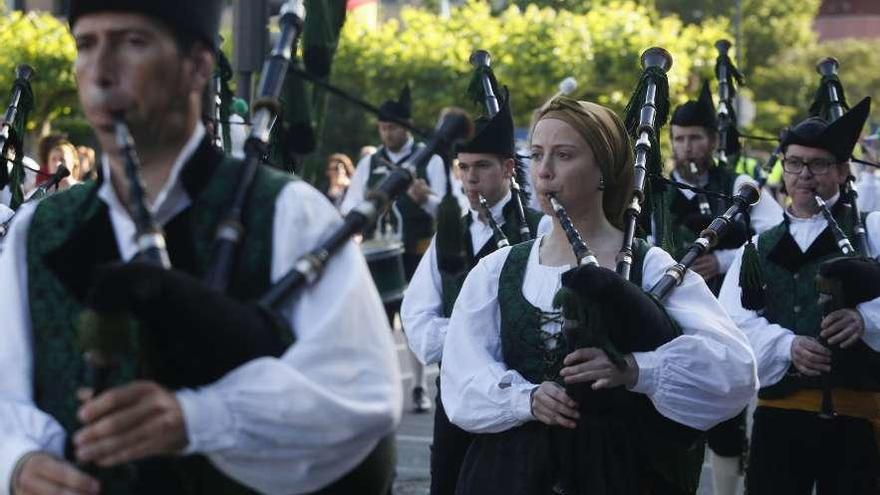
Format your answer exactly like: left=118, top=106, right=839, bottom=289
left=718, top=198, right=880, bottom=387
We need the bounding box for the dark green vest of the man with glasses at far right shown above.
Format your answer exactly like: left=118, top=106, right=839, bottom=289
left=757, top=201, right=880, bottom=398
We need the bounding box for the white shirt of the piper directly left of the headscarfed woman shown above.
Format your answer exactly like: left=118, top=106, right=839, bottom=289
left=400, top=191, right=553, bottom=364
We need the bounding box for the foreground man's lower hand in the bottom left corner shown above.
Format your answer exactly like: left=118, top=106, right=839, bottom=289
left=12, top=452, right=101, bottom=495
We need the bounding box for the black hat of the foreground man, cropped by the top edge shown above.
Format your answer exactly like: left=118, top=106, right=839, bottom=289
left=67, top=0, right=224, bottom=48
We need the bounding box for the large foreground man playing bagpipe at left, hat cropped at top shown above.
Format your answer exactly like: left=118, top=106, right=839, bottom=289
left=0, top=0, right=401, bottom=495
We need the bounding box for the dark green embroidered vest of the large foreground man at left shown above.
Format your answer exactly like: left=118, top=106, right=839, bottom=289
left=27, top=149, right=292, bottom=495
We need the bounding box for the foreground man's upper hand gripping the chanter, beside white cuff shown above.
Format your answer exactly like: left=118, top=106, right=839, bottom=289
left=73, top=381, right=188, bottom=467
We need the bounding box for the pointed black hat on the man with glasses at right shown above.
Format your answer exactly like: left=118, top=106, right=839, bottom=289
left=780, top=97, right=871, bottom=162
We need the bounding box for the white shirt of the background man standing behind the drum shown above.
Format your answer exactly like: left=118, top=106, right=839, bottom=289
left=339, top=137, right=446, bottom=217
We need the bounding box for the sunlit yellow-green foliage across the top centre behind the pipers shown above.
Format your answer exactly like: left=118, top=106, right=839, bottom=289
left=323, top=0, right=728, bottom=167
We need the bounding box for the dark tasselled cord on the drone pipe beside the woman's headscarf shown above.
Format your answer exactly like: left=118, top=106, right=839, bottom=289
left=624, top=67, right=675, bottom=253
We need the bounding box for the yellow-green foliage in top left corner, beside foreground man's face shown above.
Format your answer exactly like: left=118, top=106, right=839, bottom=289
left=0, top=11, right=78, bottom=142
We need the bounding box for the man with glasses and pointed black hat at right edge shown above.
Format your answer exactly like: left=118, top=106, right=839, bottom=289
left=720, top=99, right=880, bottom=495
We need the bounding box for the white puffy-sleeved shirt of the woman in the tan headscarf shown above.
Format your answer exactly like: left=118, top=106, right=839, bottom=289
left=440, top=237, right=757, bottom=433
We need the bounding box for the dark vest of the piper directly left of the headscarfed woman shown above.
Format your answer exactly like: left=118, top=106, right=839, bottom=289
left=437, top=198, right=543, bottom=318
